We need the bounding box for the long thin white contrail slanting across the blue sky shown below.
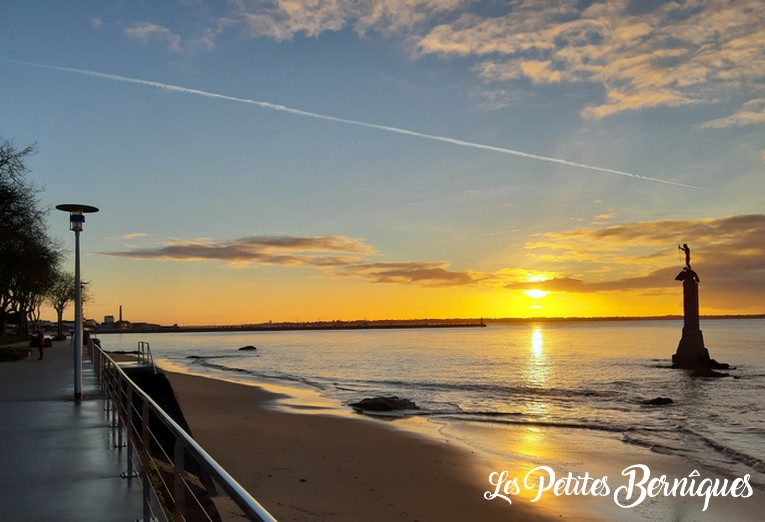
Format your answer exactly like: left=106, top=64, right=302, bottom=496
left=0, top=58, right=706, bottom=190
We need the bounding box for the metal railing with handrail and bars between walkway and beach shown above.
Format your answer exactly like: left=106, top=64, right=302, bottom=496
left=88, top=342, right=276, bottom=522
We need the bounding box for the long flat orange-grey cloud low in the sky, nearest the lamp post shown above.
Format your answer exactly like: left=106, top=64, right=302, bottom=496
left=107, top=236, right=375, bottom=267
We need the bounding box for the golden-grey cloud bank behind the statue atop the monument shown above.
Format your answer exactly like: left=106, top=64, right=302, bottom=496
left=520, top=214, right=765, bottom=309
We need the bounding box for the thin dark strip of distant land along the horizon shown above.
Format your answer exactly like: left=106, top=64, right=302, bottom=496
left=94, top=314, right=765, bottom=334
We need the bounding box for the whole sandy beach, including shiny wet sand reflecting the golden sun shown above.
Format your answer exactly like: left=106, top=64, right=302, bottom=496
left=167, top=372, right=763, bottom=522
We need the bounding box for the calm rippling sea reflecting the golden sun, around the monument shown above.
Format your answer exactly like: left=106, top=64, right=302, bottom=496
left=101, top=319, right=765, bottom=484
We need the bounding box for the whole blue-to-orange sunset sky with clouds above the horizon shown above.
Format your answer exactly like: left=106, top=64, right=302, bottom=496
left=0, top=0, right=765, bottom=325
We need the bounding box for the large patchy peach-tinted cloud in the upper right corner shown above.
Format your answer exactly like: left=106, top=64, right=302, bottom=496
left=414, top=0, right=765, bottom=121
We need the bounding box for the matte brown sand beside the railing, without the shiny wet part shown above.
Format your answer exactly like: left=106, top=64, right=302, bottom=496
left=167, top=372, right=551, bottom=522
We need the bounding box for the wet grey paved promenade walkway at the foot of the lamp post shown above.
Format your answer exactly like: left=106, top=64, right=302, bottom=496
left=0, top=341, right=142, bottom=522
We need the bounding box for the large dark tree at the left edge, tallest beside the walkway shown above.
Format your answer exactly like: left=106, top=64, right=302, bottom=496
left=0, top=139, right=62, bottom=333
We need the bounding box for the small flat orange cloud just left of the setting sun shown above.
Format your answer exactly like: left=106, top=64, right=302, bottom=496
left=336, top=261, right=478, bottom=286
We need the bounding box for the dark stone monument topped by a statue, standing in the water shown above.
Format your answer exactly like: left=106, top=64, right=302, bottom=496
left=672, top=243, right=728, bottom=372
